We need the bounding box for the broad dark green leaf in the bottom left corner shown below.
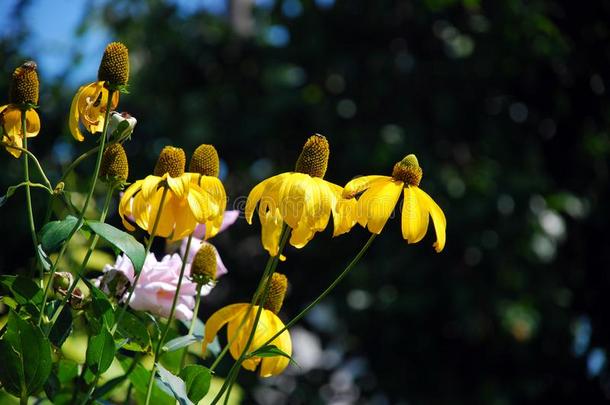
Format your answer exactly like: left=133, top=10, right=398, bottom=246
left=0, top=311, right=53, bottom=397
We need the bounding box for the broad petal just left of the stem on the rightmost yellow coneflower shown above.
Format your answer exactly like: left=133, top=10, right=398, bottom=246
left=357, top=178, right=403, bottom=234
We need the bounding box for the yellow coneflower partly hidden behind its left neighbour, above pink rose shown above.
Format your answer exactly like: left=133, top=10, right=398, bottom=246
left=189, top=144, right=227, bottom=239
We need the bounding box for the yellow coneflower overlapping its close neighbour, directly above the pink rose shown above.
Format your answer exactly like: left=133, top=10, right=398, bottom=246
left=119, top=146, right=226, bottom=241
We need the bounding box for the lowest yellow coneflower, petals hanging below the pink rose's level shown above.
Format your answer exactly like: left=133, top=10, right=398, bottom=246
left=203, top=273, right=292, bottom=377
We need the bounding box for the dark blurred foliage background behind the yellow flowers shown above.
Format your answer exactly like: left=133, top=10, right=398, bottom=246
left=0, top=0, right=610, bottom=404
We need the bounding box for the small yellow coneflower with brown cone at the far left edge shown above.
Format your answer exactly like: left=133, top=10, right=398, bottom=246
left=0, top=61, right=40, bottom=158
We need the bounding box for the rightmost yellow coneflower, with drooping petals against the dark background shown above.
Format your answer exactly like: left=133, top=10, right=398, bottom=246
left=343, top=155, right=447, bottom=252
